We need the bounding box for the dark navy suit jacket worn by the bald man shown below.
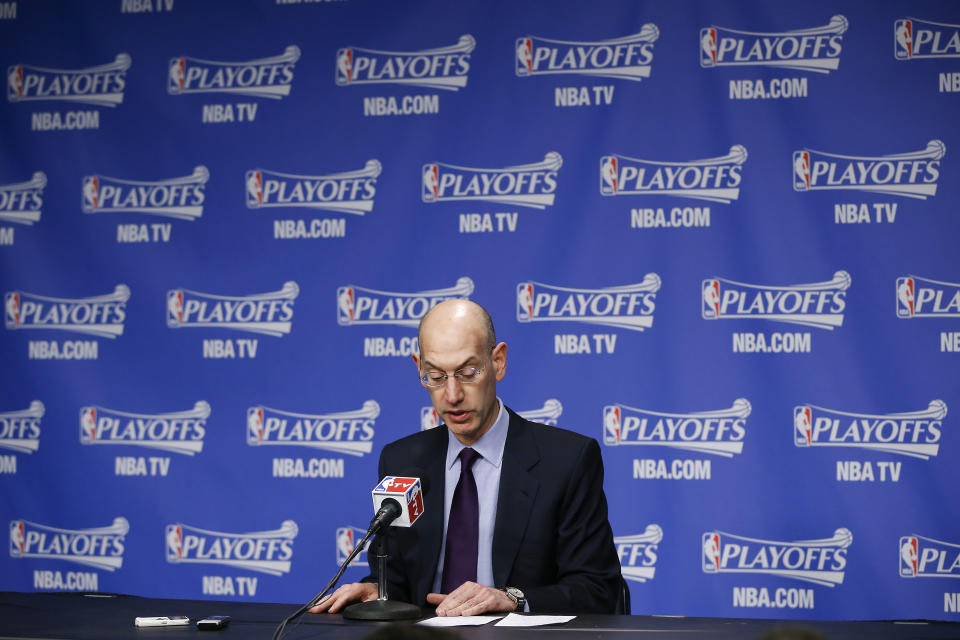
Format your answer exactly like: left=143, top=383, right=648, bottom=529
left=367, top=409, right=620, bottom=613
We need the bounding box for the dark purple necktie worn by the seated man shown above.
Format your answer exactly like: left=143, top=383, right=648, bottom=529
left=440, top=447, right=480, bottom=593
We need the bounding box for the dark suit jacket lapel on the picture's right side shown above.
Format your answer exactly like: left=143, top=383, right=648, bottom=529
left=493, top=409, right=540, bottom=587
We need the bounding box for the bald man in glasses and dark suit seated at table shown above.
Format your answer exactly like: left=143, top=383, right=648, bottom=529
left=311, top=300, right=620, bottom=615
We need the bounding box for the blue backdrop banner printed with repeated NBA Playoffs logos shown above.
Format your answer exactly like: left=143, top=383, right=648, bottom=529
left=0, top=0, right=960, bottom=621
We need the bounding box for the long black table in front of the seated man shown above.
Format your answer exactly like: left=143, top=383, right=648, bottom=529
left=0, top=592, right=960, bottom=640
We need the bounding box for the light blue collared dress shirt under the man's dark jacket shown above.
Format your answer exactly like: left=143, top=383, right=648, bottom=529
left=433, top=398, right=510, bottom=593
